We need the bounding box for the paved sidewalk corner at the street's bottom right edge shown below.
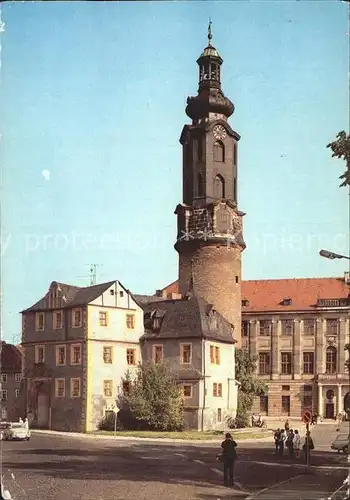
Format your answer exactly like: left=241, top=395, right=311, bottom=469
left=246, top=471, right=344, bottom=500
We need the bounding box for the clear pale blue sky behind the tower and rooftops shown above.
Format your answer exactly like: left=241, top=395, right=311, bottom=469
left=0, top=0, right=349, bottom=342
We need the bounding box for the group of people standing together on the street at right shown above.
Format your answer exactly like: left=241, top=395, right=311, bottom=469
left=274, top=420, right=315, bottom=463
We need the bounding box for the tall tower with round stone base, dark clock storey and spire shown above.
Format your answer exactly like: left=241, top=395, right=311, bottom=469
left=175, top=23, right=245, bottom=345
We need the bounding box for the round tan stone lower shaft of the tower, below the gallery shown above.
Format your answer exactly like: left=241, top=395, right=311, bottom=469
left=177, top=242, right=241, bottom=347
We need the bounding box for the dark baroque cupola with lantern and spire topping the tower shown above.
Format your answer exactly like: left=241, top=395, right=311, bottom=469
left=186, top=22, right=234, bottom=123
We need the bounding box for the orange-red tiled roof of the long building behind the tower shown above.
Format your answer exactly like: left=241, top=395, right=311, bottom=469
left=163, top=277, right=350, bottom=313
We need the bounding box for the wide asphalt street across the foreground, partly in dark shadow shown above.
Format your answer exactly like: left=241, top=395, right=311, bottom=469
left=2, top=425, right=347, bottom=500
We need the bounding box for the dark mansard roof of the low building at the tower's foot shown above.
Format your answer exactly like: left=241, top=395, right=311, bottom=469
left=142, top=296, right=236, bottom=344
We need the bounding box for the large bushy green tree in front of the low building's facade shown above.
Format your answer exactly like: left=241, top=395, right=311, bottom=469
left=124, top=363, right=184, bottom=431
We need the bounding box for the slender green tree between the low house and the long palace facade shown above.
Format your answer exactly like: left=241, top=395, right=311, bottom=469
left=236, top=349, right=267, bottom=427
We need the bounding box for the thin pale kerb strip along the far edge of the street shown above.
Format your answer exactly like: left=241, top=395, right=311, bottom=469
left=31, top=429, right=271, bottom=444
